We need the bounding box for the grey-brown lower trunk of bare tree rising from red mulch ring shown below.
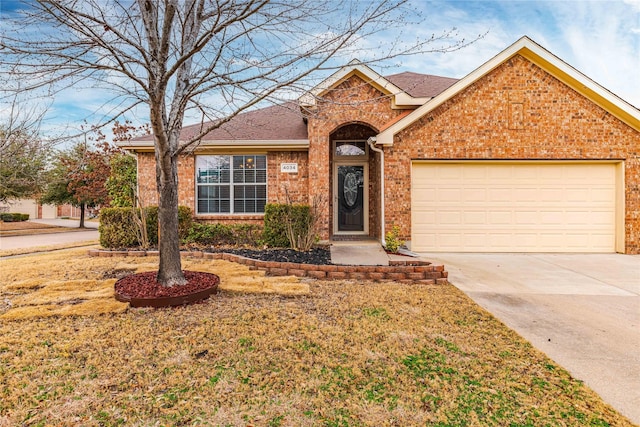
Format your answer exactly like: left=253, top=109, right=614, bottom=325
left=156, top=153, right=187, bottom=286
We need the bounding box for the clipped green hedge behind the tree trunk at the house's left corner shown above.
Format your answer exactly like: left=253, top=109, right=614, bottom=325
left=98, top=206, right=193, bottom=249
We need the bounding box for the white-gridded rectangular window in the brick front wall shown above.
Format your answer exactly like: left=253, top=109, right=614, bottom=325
left=196, top=155, right=267, bottom=214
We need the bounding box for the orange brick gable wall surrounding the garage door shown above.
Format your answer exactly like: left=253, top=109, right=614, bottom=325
left=385, top=56, right=640, bottom=254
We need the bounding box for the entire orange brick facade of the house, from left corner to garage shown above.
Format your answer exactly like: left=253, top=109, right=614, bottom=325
left=138, top=56, right=640, bottom=254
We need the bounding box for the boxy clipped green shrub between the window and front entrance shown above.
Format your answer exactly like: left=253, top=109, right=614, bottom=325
left=262, top=203, right=311, bottom=248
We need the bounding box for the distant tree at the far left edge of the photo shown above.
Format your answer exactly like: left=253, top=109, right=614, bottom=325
left=0, top=98, right=50, bottom=202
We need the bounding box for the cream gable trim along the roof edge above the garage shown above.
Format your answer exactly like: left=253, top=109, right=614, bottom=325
left=376, top=36, right=640, bottom=145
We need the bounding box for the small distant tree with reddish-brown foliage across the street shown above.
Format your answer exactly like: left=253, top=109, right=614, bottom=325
left=40, top=141, right=114, bottom=228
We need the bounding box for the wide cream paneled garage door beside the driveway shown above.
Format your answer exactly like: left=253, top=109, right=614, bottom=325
left=411, top=162, right=616, bottom=252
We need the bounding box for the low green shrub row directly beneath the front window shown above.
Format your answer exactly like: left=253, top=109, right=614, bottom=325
left=185, top=222, right=261, bottom=246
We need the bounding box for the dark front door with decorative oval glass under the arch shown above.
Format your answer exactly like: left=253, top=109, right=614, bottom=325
left=335, top=164, right=367, bottom=234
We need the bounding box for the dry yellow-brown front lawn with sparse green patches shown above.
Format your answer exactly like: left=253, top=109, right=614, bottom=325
left=0, top=251, right=632, bottom=426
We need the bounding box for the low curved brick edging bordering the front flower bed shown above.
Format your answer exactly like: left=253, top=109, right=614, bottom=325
left=89, top=249, right=449, bottom=285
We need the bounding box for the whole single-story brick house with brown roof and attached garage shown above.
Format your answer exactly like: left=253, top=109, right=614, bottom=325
left=123, top=37, right=640, bottom=254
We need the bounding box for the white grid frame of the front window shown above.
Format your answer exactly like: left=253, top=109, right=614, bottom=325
left=194, top=153, right=269, bottom=216
